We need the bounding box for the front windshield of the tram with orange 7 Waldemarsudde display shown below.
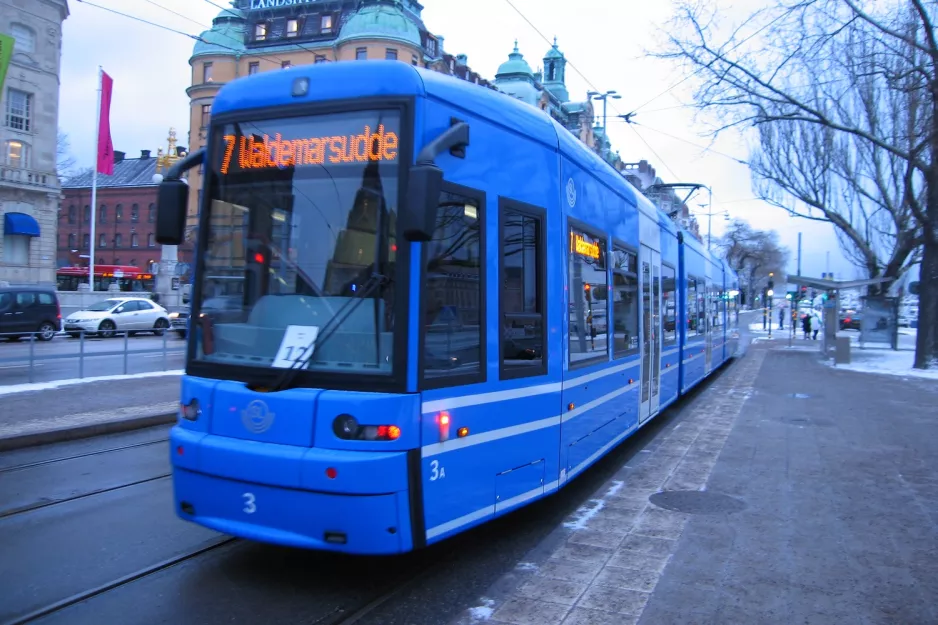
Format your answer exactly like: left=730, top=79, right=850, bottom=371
left=193, top=111, right=401, bottom=374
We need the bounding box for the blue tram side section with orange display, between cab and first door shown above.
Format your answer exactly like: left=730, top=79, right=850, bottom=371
left=557, top=145, right=641, bottom=480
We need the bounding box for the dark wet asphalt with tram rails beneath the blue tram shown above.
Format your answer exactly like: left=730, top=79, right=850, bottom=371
left=0, top=366, right=728, bottom=625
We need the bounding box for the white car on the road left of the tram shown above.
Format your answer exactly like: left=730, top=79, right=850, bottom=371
left=63, top=297, right=170, bottom=338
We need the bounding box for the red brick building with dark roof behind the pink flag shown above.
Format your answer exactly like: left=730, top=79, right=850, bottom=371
left=57, top=150, right=192, bottom=270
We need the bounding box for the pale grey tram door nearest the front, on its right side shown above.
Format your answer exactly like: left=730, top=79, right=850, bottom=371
left=639, top=245, right=661, bottom=422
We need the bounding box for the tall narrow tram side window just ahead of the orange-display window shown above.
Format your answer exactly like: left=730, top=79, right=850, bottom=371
left=499, top=200, right=547, bottom=379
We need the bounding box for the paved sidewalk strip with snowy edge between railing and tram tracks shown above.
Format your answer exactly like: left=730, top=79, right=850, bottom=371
left=0, top=373, right=180, bottom=452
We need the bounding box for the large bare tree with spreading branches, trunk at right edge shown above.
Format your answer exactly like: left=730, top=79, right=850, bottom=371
left=662, top=0, right=938, bottom=368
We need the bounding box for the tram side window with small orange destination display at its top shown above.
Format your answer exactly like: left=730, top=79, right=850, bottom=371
left=567, top=227, right=609, bottom=367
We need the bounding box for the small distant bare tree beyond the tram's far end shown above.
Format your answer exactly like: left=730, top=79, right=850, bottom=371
left=717, top=219, right=789, bottom=306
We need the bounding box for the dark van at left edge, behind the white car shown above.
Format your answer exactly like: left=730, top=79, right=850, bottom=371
left=0, top=286, right=62, bottom=341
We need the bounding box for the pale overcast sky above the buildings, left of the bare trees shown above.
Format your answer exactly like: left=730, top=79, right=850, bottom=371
left=59, top=0, right=857, bottom=278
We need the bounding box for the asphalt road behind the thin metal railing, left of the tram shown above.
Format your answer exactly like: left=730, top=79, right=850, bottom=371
left=0, top=333, right=186, bottom=385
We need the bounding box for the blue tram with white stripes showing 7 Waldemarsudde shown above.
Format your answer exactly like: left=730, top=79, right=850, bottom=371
left=157, top=61, right=737, bottom=554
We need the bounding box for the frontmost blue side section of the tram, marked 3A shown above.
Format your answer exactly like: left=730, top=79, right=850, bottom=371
left=417, top=95, right=562, bottom=543
